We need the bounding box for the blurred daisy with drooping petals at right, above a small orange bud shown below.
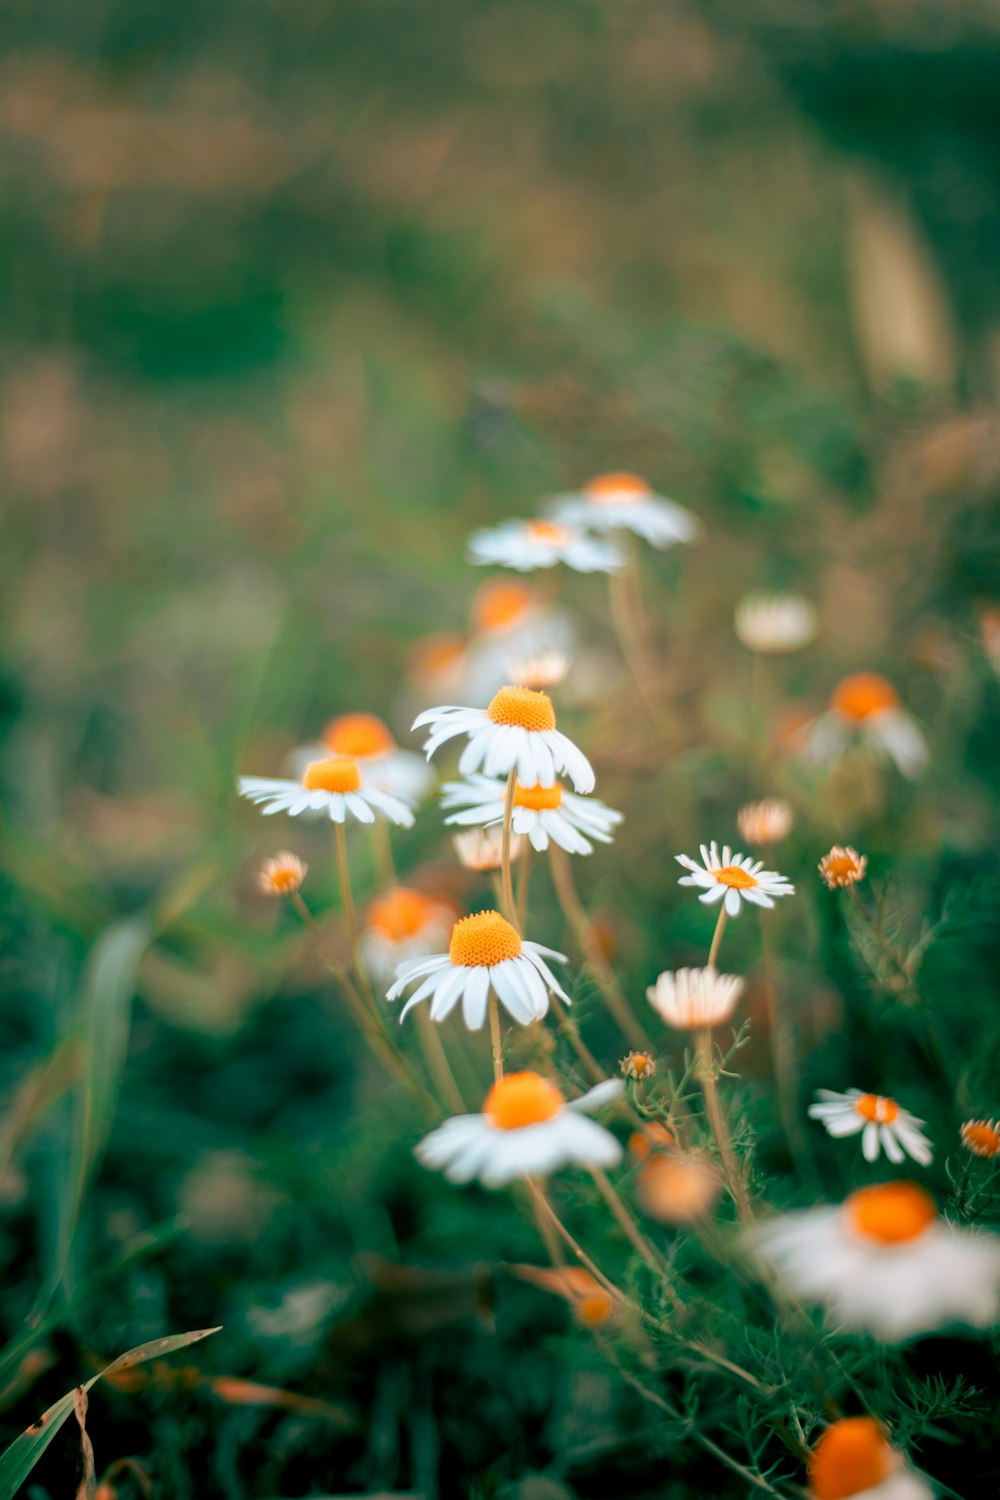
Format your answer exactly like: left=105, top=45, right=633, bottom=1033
left=802, top=672, right=928, bottom=780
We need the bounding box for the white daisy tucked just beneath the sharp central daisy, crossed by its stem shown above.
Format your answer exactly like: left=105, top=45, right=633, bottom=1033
left=441, top=776, right=622, bottom=854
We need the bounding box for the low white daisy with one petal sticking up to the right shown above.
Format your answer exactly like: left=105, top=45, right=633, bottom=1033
left=415, top=1073, right=622, bottom=1188
